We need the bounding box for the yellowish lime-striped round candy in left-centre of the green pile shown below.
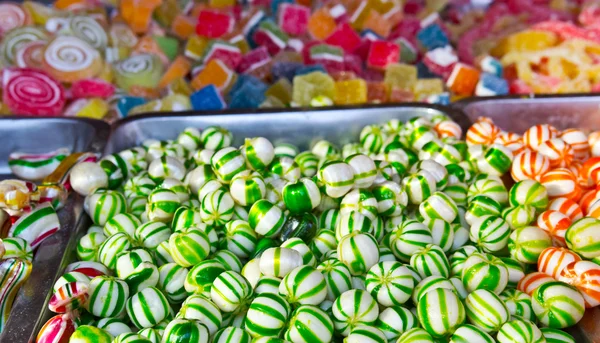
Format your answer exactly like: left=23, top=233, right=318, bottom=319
left=169, top=229, right=210, bottom=267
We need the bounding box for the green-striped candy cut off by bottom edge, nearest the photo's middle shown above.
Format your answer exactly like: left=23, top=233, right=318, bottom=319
left=284, top=305, right=333, bottom=343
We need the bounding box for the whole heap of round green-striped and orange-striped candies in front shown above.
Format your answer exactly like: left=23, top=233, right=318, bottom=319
left=28, top=115, right=600, bottom=343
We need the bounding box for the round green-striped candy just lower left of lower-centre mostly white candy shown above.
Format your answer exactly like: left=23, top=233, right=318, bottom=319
left=210, top=271, right=252, bottom=312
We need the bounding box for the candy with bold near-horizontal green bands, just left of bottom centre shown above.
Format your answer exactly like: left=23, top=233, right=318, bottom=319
left=245, top=293, right=291, bottom=338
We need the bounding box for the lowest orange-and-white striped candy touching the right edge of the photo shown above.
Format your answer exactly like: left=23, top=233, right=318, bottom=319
left=558, top=261, right=600, bottom=308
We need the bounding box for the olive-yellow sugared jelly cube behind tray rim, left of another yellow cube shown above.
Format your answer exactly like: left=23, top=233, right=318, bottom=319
left=292, top=71, right=335, bottom=106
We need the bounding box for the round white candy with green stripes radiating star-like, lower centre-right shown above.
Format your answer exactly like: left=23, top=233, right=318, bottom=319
left=365, top=261, right=415, bottom=307
